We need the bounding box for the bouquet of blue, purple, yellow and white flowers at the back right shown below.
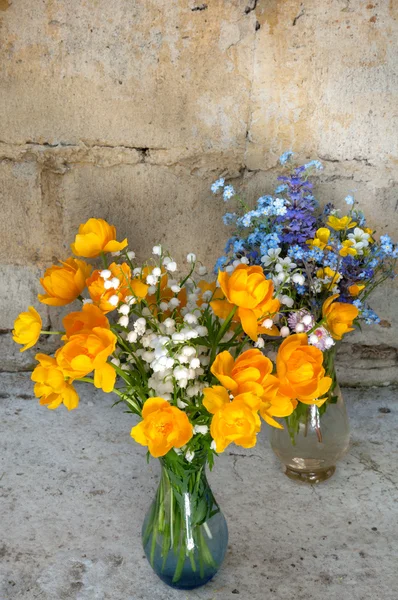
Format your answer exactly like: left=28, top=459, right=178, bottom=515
left=211, top=152, right=398, bottom=442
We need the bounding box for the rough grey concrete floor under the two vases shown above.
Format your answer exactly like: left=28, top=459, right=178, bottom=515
left=0, top=374, right=398, bottom=600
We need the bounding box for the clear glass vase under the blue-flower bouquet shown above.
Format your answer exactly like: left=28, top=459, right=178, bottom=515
left=270, top=383, right=350, bottom=483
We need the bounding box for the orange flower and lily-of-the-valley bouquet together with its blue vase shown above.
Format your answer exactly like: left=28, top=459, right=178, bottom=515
left=13, top=219, right=328, bottom=587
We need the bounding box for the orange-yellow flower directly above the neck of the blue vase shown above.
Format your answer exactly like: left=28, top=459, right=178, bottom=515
left=131, top=398, right=193, bottom=458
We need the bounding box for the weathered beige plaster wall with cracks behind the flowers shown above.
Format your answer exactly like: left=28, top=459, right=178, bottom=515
left=0, top=0, right=398, bottom=382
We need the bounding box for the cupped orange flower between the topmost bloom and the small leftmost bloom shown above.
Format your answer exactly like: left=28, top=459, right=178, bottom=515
left=38, top=258, right=92, bottom=306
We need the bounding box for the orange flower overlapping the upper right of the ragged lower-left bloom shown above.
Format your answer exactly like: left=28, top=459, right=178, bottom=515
left=55, top=327, right=116, bottom=392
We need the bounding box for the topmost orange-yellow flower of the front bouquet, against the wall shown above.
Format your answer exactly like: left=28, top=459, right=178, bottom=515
left=71, top=219, right=128, bottom=258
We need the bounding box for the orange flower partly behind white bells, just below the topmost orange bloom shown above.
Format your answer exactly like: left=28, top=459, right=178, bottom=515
left=87, top=263, right=149, bottom=313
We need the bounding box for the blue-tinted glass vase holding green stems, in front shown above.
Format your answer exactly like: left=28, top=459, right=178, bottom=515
left=142, top=451, right=228, bottom=590
